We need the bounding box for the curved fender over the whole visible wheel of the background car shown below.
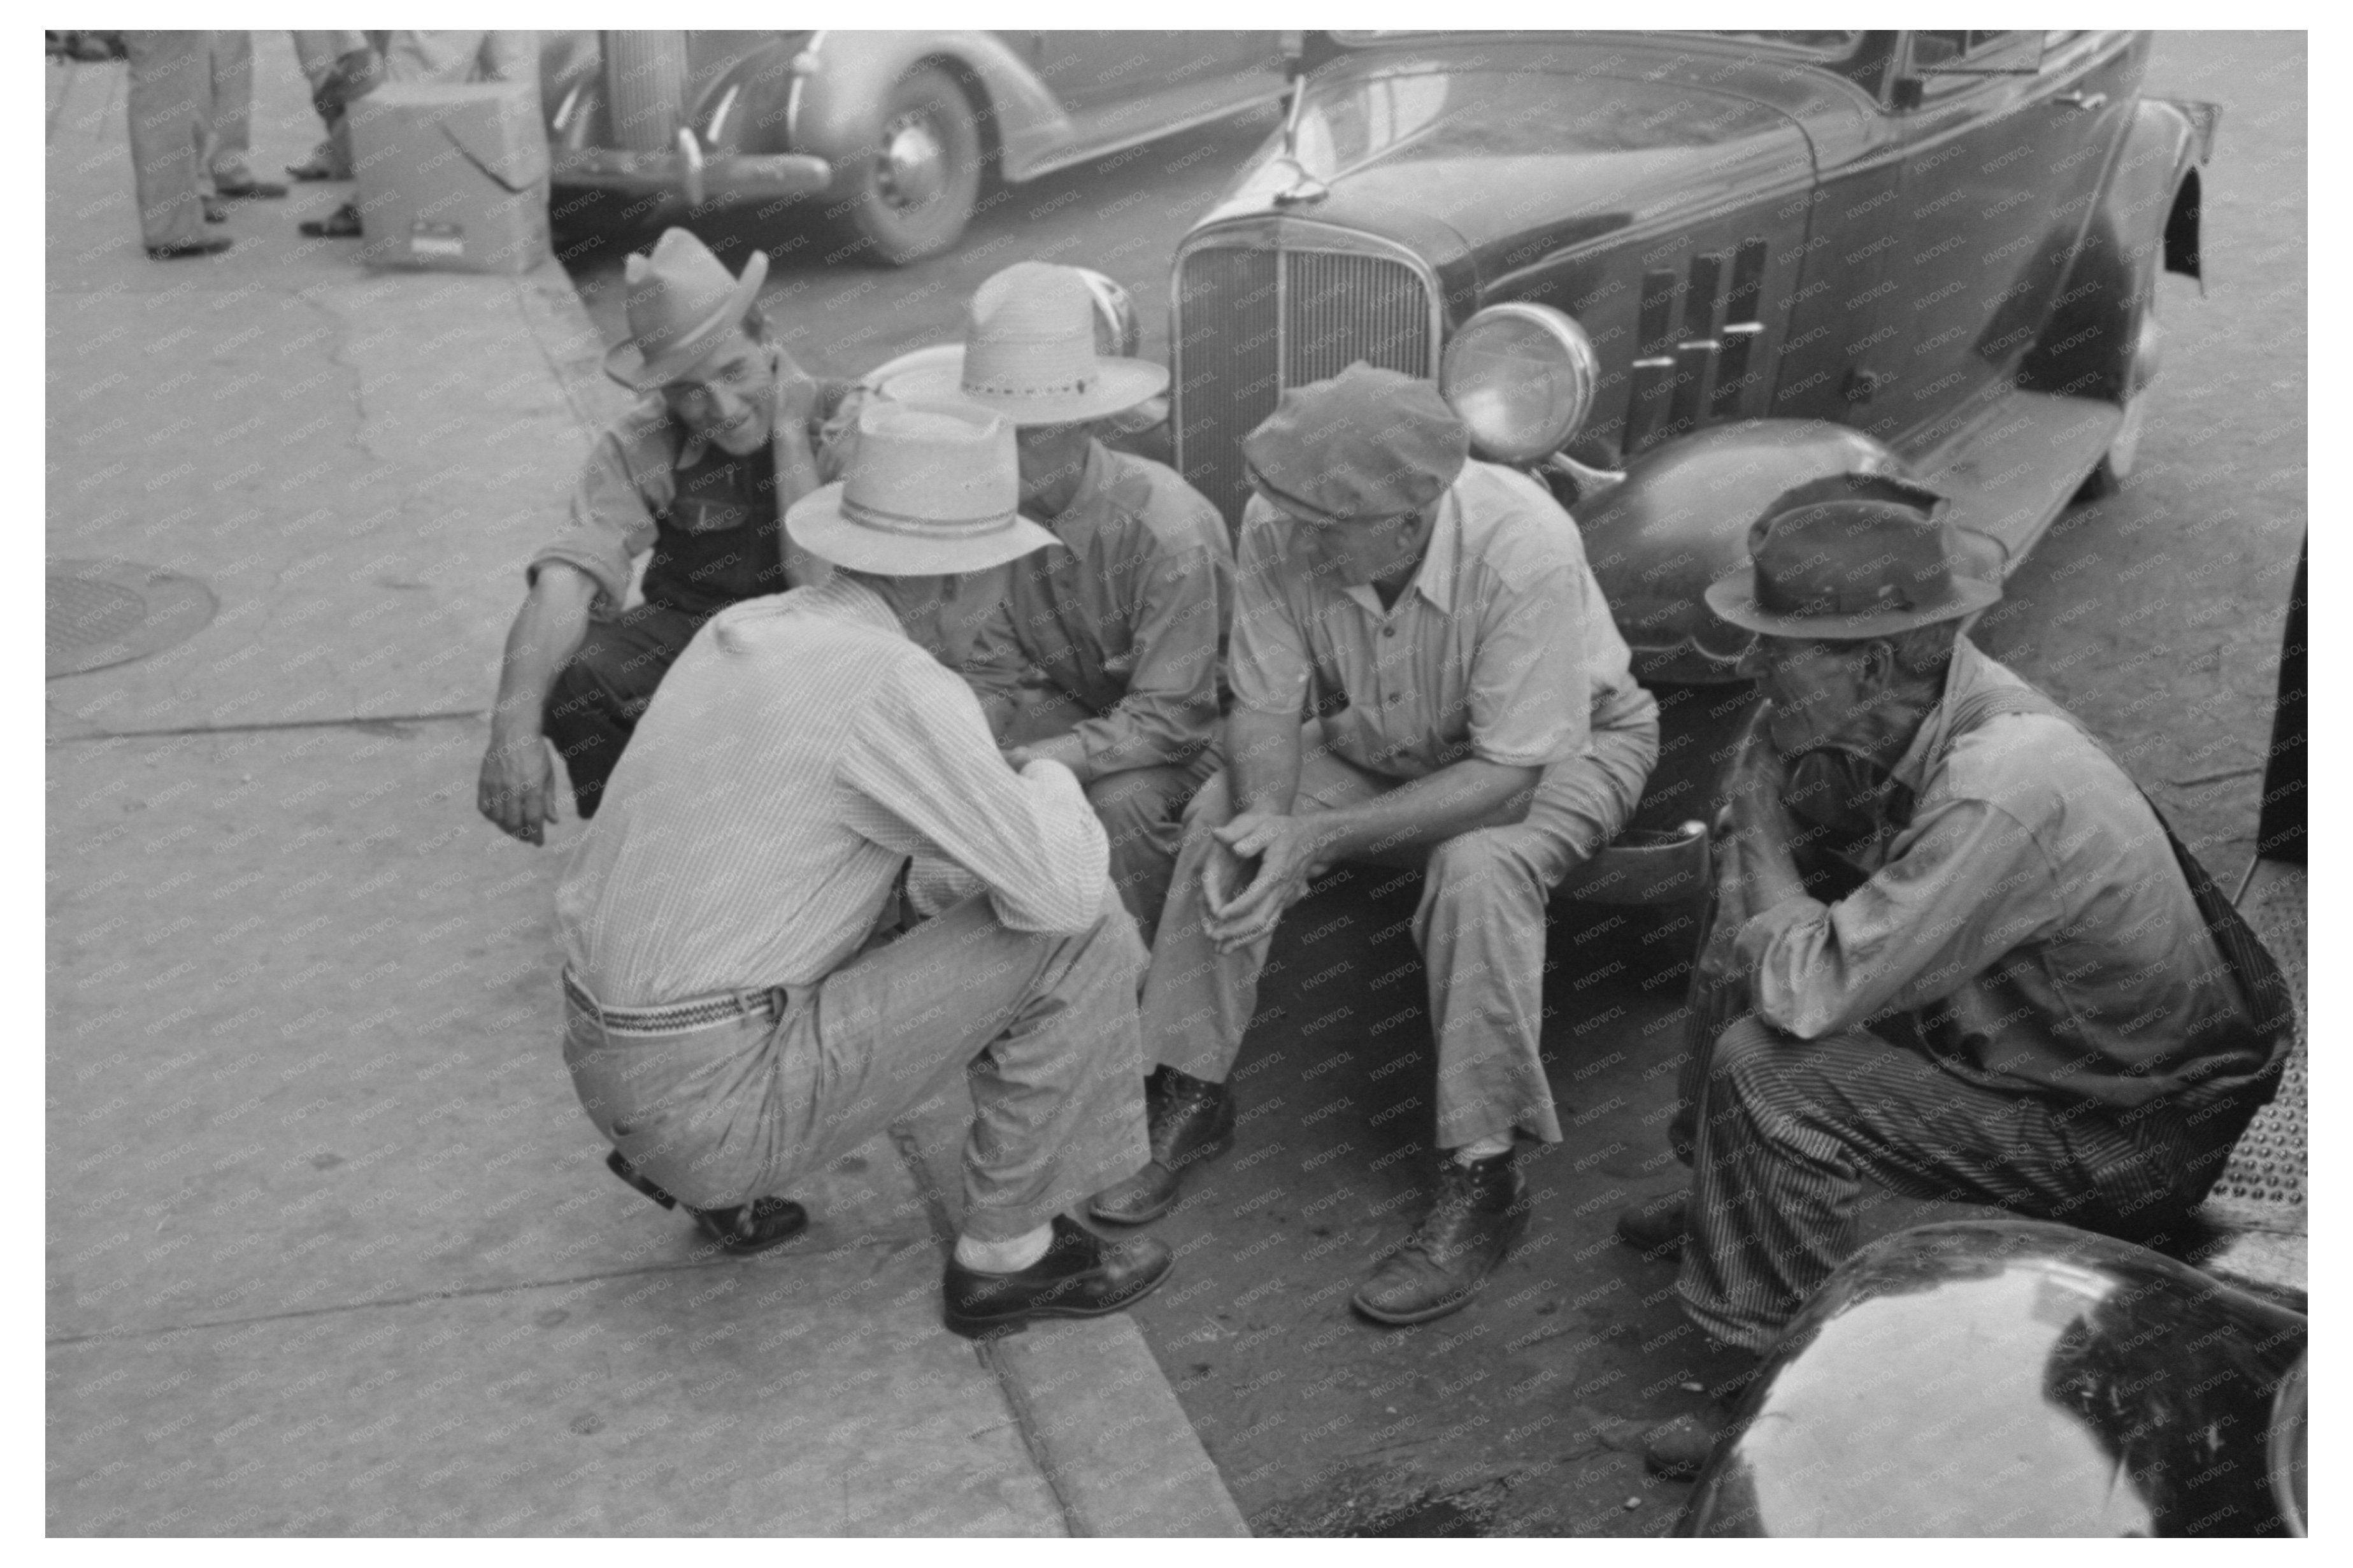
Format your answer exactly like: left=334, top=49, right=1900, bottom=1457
left=790, top=31, right=1075, bottom=183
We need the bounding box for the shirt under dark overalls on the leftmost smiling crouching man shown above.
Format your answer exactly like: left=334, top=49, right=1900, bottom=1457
left=527, top=362, right=857, bottom=612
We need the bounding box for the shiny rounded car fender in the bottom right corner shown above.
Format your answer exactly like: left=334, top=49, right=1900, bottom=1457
left=1675, top=1220, right=2311, bottom=1537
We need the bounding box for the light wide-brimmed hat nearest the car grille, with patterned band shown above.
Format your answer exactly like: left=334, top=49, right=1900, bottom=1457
left=878, top=261, right=1169, bottom=424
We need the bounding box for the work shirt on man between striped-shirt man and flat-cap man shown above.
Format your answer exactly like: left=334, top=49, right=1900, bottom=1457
left=965, top=443, right=1233, bottom=780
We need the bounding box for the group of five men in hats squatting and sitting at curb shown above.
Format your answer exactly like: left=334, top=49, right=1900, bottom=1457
left=478, top=231, right=2285, bottom=1469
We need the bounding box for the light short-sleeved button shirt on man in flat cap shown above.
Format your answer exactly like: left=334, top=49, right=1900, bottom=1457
left=1228, top=462, right=1647, bottom=780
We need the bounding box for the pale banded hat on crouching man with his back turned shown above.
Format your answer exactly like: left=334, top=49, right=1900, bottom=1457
left=783, top=403, right=1061, bottom=577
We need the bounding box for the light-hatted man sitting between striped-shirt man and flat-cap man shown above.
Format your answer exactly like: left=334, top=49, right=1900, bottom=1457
left=878, top=261, right=1233, bottom=942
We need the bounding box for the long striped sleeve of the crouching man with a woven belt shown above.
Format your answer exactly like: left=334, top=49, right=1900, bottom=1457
left=840, top=664, right=1111, bottom=932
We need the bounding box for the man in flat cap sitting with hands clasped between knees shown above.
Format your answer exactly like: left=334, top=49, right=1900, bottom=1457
left=1092, top=365, right=1659, bottom=1323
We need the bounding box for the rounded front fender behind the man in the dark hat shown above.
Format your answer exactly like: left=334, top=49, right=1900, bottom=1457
left=1572, top=419, right=1903, bottom=683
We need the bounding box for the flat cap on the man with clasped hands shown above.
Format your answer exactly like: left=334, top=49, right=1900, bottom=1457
left=1242, top=360, right=1471, bottom=523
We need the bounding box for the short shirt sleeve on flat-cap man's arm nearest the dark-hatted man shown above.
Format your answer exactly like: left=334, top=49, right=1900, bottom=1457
left=1471, top=565, right=1593, bottom=767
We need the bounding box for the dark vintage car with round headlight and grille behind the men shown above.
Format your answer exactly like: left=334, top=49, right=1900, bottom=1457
left=1169, top=31, right=2217, bottom=902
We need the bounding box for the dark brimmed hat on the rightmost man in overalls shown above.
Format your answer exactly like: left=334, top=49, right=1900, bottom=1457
left=1708, top=476, right=2003, bottom=643
